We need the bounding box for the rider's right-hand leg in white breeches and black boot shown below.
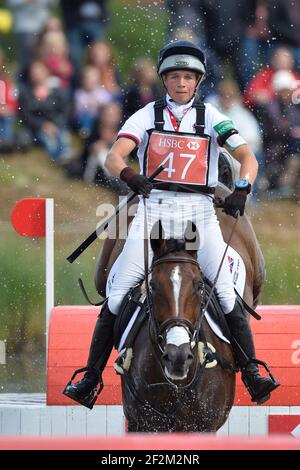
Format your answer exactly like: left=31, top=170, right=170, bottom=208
left=198, top=206, right=279, bottom=403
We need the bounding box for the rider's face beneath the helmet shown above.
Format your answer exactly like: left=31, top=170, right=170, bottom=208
left=163, top=70, right=198, bottom=104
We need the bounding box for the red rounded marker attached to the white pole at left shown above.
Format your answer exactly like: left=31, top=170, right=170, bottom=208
left=11, top=198, right=46, bottom=238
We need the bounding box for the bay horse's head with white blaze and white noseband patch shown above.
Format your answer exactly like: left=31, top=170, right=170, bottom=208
left=150, top=221, right=204, bottom=381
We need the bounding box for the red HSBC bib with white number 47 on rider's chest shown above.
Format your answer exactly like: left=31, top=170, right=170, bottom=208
left=145, top=130, right=210, bottom=189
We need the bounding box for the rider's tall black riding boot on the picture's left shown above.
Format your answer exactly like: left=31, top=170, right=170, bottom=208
left=63, top=302, right=116, bottom=409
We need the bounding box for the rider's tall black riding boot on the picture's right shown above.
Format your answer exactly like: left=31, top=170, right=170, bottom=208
left=225, top=301, right=280, bottom=404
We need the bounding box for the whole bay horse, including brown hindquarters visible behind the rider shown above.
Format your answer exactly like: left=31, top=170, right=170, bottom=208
left=95, top=152, right=265, bottom=432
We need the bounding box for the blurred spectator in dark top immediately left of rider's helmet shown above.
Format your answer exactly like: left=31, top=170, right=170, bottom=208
left=123, top=57, right=160, bottom=120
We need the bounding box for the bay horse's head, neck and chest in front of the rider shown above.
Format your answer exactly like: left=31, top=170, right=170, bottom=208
left=122, top=222, right=235, bottom=432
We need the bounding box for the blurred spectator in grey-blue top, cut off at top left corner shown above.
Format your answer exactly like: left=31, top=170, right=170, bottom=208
left=6, top=0, right=57, bottom=81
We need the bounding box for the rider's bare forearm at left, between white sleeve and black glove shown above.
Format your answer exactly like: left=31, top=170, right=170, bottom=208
left=105, top=137, right=136, bottom=177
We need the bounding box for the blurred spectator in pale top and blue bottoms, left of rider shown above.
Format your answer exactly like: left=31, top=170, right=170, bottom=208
left=75, top=65, right=112, bottom=138
